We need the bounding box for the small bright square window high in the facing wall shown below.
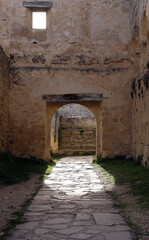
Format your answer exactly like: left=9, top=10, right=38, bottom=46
left=32, top=12, right=47, bottom=29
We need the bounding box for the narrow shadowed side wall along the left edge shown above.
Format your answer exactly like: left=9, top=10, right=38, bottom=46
left=0, top=46, right=9, bottom=152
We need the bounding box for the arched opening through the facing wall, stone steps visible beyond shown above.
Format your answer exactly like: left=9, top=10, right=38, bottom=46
left=50, top=103, right=96, bottom=155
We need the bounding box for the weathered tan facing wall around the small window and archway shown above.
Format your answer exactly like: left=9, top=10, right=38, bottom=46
left=0, top=0, right=131, bottom=157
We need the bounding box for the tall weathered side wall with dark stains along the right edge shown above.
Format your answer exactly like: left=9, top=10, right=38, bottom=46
left=131, top=0, right=149, bottom=167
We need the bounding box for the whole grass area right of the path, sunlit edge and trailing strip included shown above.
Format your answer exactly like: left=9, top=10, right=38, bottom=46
left=93, top=156, right=149, bottom=240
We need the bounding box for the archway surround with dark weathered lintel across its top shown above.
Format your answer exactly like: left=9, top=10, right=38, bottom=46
left=43, top=94, right=103, bottom=161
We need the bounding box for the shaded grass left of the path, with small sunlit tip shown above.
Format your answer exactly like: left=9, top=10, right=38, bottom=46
left=0, top=153, right=54, bottom=185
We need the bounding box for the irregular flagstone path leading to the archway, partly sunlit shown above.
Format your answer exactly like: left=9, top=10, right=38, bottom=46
left=9, top=157, right=132, bottom=240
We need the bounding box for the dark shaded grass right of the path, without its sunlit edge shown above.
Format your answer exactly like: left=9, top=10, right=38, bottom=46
left=93, top=157, right=149, bottom=208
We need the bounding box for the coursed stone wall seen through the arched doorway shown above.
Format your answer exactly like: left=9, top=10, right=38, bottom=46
left=58, top=116, right=96, bottom=154
